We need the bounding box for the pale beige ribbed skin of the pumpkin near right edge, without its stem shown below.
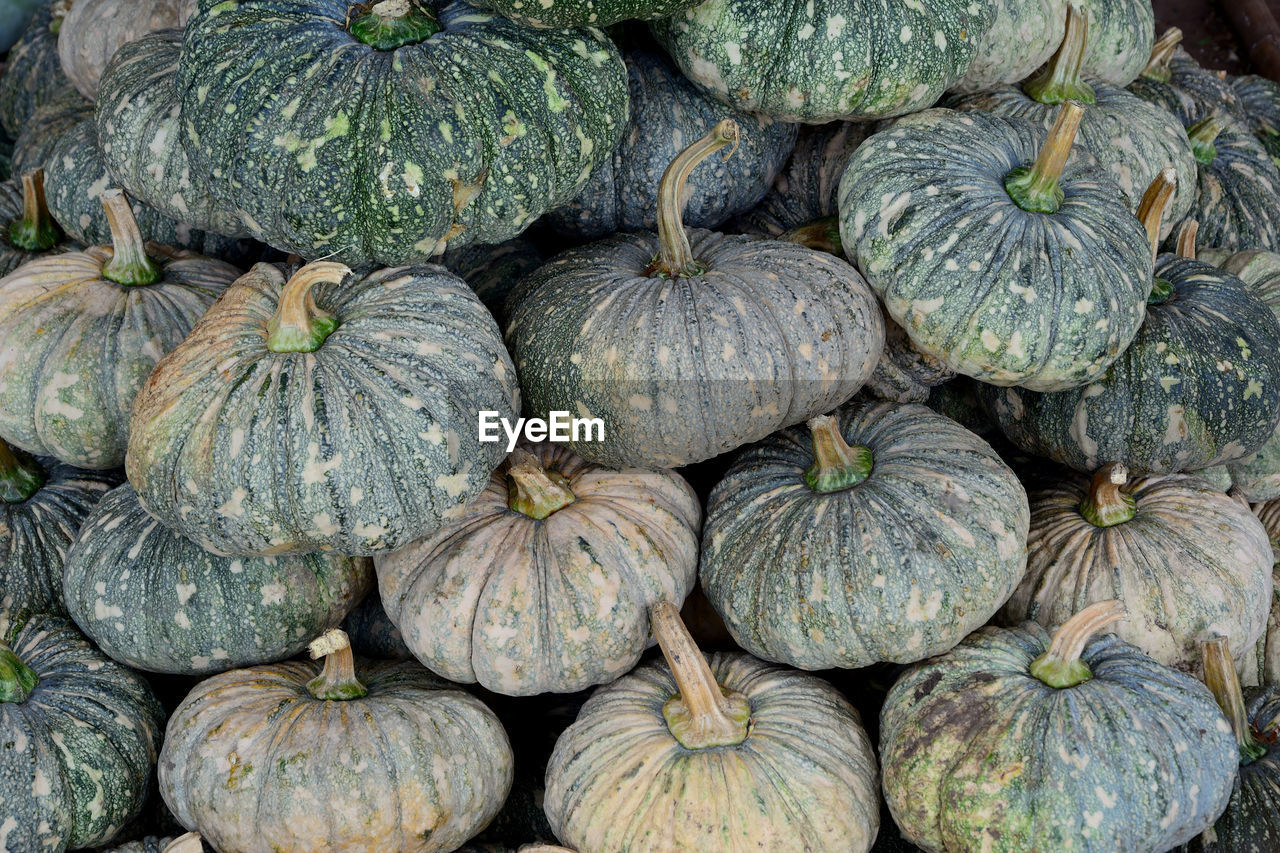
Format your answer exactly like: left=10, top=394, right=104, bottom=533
left=1001, top=474, right=1274, bottom=672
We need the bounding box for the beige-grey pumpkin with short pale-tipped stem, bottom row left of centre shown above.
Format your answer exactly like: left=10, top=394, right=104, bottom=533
left=159, top=630, right=512, bottom=853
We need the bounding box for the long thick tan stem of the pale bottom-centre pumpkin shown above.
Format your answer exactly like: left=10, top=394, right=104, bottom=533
left=649, top=601, right=751, bottom=749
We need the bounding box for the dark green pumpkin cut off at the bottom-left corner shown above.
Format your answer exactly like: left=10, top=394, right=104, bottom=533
left=0, top=607, right=164, bottom=850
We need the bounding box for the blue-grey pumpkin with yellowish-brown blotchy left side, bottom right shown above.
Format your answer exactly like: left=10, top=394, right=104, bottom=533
left=881, top=602, right=1236, bottom=853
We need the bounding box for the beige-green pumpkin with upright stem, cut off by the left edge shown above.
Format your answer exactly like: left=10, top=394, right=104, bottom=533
left=0, top=190, right=239, bottom=470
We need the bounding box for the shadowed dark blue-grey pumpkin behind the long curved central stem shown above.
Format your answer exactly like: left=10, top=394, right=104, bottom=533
left=547, top=45, right=796, bottom=240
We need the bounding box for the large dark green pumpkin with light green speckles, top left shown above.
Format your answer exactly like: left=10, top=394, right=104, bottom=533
left=178, top=0, right=627, bottom=264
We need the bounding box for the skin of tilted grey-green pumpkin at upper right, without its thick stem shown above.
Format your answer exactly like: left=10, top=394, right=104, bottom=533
left=840, top=110, right=1151, bottom=391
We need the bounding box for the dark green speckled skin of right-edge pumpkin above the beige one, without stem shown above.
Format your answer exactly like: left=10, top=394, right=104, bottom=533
left=984, top=255, right=1280, bottom=474
